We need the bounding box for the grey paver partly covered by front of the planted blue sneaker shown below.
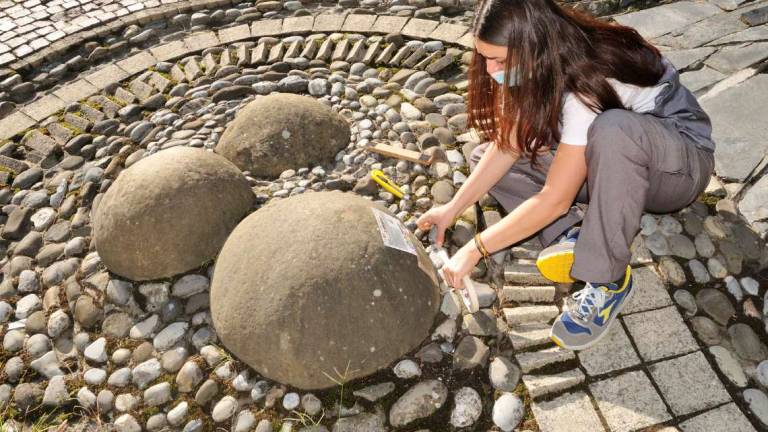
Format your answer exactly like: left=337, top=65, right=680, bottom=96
left=577, top=322, right=640, bottom=376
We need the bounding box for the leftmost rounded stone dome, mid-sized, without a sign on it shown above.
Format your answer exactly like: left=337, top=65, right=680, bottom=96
left=93, top=147, right=254, bottom=280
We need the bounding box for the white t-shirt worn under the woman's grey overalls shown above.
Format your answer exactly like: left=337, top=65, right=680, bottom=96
left=560, top=78, right=669, bottom=146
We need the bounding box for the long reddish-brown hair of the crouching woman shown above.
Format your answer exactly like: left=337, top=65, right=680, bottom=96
left=467, top=0, right=664, bottom=164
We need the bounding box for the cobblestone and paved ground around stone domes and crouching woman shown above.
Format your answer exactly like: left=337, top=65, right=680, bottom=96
left=0, top=0, right=768, bottom=432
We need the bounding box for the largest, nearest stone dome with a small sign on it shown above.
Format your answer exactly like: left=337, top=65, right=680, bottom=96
left=211, top=191, right=440, bottom=390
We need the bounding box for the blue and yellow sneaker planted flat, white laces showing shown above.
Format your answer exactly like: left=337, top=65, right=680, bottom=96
left=549, top=266, right=634, bottom=351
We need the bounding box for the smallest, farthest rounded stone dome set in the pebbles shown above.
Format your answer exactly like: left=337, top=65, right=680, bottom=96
left=216, top=93, right=350, bottom=178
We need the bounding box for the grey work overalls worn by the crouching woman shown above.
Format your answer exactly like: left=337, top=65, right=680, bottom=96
left=469, top=58, right=715, bottom=282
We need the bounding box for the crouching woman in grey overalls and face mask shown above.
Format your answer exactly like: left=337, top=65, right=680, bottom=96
left=417, top=0, right=714, bottom=350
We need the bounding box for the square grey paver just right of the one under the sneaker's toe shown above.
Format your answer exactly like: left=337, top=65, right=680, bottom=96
left=624, top=306, right=699, bottom=361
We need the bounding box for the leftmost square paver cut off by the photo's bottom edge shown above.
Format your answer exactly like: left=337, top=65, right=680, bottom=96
left=531, top=392, right=605, bottom=432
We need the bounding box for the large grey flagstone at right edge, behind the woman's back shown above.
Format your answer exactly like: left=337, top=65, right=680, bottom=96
left=701, top=75, right=768, bottom=180
